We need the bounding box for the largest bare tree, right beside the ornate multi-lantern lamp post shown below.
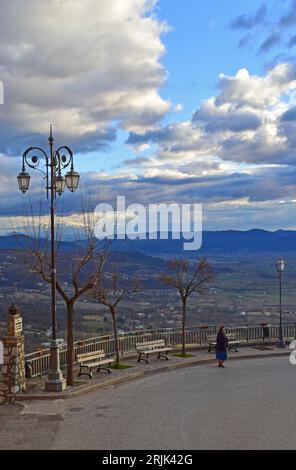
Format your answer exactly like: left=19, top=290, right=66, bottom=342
left=10, top=201, right=110, bottom=386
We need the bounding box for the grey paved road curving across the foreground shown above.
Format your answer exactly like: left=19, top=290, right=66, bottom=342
left=0, top=357, right=296, bottom=450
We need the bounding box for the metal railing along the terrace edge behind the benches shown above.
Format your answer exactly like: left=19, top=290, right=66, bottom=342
left=26, top=324, right=296, bottom=377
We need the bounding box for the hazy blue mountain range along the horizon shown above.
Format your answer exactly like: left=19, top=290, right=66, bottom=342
left=0, top=229, right=296, bottom=257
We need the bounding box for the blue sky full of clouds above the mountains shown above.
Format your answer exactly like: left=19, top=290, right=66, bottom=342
left=0, top=0, right=296, bottom=230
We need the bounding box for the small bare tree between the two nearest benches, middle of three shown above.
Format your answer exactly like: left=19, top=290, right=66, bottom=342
left=92, top=272, right=140, bottom=365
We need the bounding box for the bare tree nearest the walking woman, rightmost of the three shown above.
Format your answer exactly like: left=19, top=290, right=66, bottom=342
left=160, top=258, right=214, bottom=356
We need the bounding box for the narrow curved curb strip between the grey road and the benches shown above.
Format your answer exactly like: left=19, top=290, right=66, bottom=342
left=12, top=351, right=291, bottom=401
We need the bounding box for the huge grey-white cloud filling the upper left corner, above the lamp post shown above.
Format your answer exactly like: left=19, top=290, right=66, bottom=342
left=0, top=0, right=170, bottom=153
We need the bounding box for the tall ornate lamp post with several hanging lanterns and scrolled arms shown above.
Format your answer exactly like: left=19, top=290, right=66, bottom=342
left=17, top=125, right=80, bottom=392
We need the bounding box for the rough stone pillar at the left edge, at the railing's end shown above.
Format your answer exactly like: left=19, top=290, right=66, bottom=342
left=0, top=304, right=26, bottom=397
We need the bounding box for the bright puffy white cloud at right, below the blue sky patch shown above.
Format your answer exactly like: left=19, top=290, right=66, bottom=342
left=128, top=64, right=296, bottom=165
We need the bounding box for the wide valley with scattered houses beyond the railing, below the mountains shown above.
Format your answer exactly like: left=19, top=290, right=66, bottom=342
left=0, top=232, right=296, bottom=352
